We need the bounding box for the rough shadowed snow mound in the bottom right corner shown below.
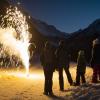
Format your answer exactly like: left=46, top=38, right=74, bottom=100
left=66, top=83, right=100, bottom=100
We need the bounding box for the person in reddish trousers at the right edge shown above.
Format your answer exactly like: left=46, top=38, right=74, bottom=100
left=91, top=38, right=100, bottom=83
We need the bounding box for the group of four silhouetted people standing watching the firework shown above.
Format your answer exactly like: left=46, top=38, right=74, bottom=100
left=40, top=38, right=100, bottom=95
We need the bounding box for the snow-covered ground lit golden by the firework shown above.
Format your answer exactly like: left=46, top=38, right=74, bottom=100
left=0, top=65, right=100, bottom=100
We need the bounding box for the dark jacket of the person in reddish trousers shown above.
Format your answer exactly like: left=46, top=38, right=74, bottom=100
left=91, top=44, right=100, bottom=67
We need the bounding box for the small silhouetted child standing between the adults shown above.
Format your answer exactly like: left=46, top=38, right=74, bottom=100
left=74, top=50, right=86, bottom=86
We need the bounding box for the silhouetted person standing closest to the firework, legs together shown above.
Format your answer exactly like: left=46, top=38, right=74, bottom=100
left=40, top=42, right=55, bottom=95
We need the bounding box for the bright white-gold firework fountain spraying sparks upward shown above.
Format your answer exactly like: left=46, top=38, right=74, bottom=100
left=0, top=7, right=30, bottom=74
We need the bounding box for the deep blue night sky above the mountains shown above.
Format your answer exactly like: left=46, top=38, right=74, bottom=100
left=12, top=0, right=100, bottom=33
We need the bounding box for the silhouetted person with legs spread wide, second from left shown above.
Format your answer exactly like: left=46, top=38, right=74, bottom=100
left=56, top=41, right=73, bottom=91
